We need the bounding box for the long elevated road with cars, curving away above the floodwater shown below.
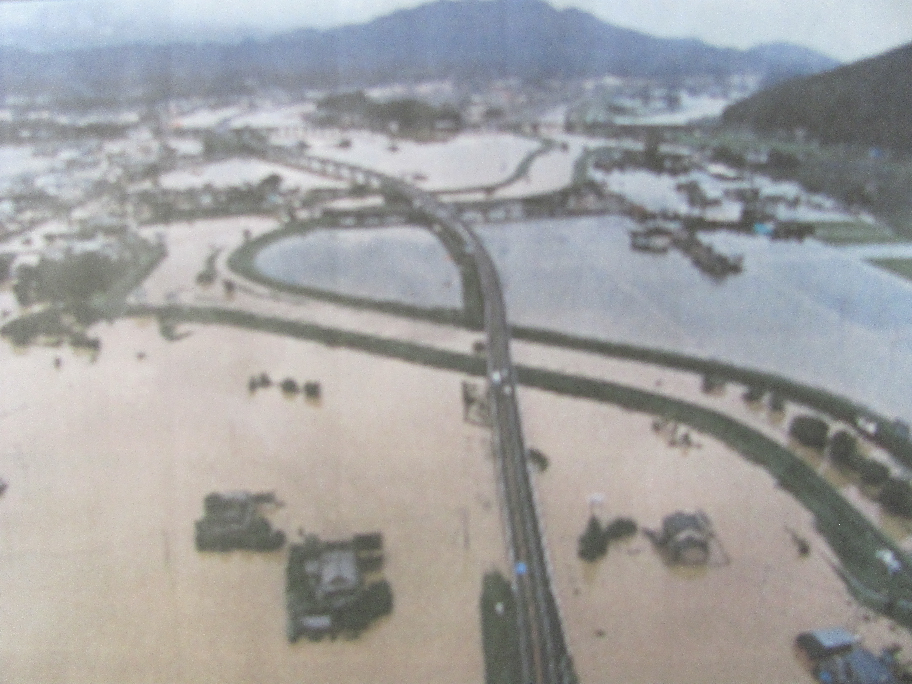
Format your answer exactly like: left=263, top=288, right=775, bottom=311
left=261, top=148, right=577, bottom=684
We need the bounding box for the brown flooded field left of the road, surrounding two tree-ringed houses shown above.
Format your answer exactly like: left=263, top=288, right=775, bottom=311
left=0, top=320, right=505, bottom=684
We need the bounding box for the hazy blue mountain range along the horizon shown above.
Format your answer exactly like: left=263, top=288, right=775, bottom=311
left=0, top=0, right=836, bottom=99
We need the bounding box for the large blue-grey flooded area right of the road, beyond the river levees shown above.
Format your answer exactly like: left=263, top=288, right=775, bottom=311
left=479, top=216, right=912, bottom=419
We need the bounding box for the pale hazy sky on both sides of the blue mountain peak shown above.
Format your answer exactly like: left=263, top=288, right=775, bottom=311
left=0, top=0, right=912, bottom=61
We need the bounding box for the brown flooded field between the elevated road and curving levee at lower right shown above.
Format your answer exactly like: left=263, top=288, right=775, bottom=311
left=521, top=390, right=912, bottom=684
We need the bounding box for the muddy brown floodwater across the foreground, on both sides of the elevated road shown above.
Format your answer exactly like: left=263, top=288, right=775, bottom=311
left=0, top=312, right=912, bottom=684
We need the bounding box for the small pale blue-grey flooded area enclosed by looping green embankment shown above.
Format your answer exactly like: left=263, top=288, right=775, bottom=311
left=254, top=226, right=462, bottom=308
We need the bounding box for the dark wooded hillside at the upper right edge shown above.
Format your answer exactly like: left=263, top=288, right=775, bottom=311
left=722, top=43, right=912, bottom=151
